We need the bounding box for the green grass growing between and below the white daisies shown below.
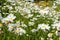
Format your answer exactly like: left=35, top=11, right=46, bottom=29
left=0, top=0, right=60, bottom=40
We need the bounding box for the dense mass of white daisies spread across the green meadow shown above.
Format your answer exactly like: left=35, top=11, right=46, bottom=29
left=0, top=0, right=60, bottom=40
